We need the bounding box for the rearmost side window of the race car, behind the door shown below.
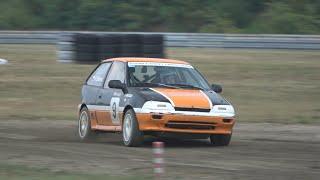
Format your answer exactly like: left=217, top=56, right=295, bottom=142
left=87, top=63, right=111, bottom=86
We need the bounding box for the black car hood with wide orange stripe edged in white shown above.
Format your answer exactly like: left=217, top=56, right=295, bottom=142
left=129, top=87, right=230, bottom=109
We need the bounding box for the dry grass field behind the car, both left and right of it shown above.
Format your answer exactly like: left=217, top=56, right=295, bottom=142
left=0, top=45, right=320, bottom=123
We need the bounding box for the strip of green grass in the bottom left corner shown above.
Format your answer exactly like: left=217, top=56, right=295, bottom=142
left=0, top=164, right=144, bottom=180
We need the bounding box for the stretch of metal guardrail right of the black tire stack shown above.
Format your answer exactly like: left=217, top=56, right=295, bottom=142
left=166, top=33, right=320, bottom=49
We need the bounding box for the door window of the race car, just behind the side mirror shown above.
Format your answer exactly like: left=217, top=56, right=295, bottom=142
left=104, top=61, right=126, bottom=88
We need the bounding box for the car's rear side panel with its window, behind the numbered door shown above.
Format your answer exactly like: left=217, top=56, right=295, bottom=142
left=81, top=62, right=111, bottom=119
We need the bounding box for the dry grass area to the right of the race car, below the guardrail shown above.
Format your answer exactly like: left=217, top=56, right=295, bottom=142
left=169, top=49, right=320, bottom=123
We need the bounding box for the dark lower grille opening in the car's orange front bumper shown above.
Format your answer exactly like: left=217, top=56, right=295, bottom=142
left=166, top=121, right=215, bottom=130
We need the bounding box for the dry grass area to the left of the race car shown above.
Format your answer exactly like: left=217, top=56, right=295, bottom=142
left=0, top=45, right=94, bottom=119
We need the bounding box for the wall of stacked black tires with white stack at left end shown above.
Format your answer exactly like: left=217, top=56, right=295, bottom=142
left=58, top=33, right=165, bottom=64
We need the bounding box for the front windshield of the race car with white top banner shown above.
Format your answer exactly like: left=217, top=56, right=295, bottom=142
left=128, top=62, right=210, bottom=90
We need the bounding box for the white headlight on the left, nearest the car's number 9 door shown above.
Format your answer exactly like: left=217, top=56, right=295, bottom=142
left=141, top=101, right=174, bottom=113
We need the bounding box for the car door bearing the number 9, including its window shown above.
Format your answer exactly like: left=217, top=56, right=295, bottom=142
left=97, top=61, right=126, bottom=126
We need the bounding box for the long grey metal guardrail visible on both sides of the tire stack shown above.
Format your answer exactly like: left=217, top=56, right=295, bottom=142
left=0, top=31, right=320, bottom=50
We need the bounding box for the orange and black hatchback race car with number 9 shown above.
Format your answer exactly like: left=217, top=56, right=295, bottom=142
left=78, top=58, right=235, bottom=146
